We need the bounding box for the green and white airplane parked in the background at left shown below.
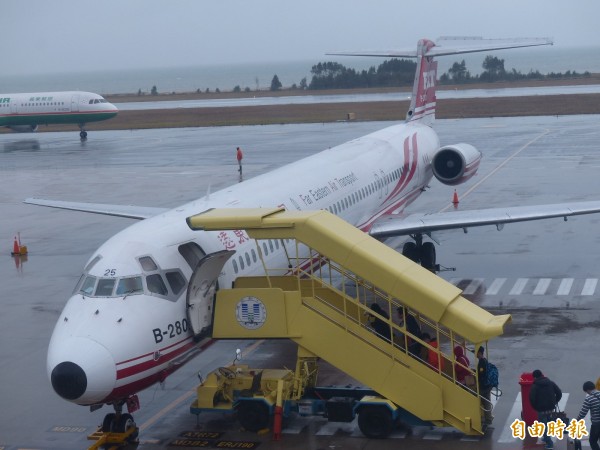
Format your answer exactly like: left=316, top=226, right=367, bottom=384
left=0, top=91, right=119, bottom=140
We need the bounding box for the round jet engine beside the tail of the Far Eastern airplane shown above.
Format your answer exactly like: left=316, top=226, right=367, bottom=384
left=431, top=143, right=481, bottom=186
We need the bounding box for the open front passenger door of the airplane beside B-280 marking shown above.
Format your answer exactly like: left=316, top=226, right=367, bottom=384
left=187, top=250, right=235, bottom=335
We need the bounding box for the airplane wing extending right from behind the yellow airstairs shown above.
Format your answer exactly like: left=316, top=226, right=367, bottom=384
left=369, top=201, right=600, bottom=239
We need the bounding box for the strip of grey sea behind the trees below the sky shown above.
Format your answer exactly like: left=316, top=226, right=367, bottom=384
left=0, top=47, right=600, bottom=95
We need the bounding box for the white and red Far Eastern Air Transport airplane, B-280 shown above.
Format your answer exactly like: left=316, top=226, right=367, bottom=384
left=26, top=38, right=600, bottom=431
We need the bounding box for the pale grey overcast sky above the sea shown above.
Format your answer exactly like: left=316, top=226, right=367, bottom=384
left=0, top=0, right=600, bottom=75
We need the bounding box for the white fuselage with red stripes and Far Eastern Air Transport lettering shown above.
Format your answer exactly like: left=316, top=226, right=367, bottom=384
left=47, top=122, right=440, bottom=405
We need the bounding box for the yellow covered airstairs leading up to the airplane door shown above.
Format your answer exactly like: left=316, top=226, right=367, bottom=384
left=187, top=208, right=510, bottom=435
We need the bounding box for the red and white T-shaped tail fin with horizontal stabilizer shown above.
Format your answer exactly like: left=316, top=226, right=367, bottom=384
left=328, top=37, right=553, bottom=124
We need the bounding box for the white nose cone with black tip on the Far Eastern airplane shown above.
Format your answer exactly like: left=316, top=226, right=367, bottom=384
left=47, top=336, right=116, bottom=405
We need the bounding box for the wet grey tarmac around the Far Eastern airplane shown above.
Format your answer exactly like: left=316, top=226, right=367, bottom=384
left=0, top=116, right=600, bottom=450
